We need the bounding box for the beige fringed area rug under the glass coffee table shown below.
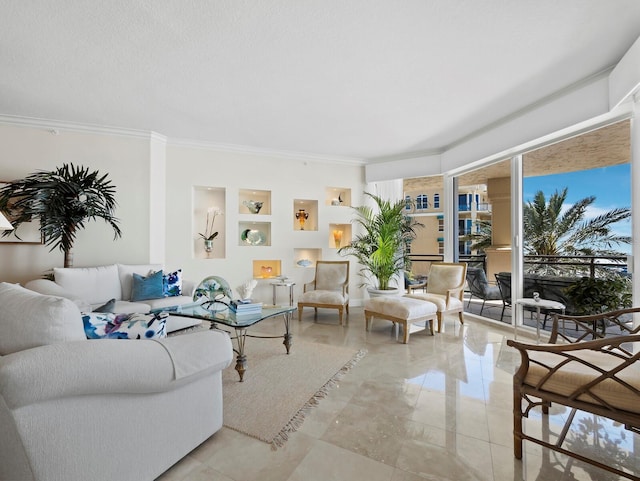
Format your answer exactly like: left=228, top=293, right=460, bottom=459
left=222, top=333, right=366, bottom=449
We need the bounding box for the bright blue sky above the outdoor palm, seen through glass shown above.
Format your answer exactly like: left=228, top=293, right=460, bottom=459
left=523, top=164, right=631, bottom=253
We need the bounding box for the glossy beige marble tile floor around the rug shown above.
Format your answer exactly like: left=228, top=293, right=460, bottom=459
left=158, top=307, right=640, bottom=481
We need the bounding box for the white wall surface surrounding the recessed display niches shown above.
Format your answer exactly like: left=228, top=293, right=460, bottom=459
left=166, top=145, right=364, bottom=303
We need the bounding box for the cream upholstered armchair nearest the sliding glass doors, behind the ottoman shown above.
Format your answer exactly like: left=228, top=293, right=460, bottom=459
left=406, top=262, right=467, bottom=332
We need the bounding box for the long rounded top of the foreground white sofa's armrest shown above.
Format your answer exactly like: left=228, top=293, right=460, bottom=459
left=0, top=331, right=233, bottom=408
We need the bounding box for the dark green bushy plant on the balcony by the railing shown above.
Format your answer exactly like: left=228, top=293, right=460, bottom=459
left=565, top=275, right=632, bottom=315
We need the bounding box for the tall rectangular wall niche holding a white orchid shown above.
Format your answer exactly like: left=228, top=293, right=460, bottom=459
left=191, top=186, right=226, bottom=259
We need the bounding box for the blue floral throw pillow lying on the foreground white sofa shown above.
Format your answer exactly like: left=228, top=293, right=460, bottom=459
left=82, top=312, right=169, bottom=339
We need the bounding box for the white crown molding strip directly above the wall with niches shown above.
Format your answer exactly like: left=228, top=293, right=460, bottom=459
left=167, top=135, right=367, bottom=165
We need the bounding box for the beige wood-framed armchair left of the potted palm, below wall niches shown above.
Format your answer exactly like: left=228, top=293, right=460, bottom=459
left=298, top=261, right=349, bottom=325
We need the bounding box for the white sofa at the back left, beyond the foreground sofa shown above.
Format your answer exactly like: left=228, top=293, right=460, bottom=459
left=25, top=264, right=200, bottom=332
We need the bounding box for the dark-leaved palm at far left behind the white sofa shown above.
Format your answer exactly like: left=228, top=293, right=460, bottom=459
left=0, top=164, right=122, bottom=267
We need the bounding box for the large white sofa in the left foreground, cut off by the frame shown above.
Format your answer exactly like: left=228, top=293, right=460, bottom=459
left=0, top=283, right=233, bottom=481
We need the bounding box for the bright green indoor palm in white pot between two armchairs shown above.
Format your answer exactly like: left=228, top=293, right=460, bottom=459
left=338, top=192, right=424, bottom=295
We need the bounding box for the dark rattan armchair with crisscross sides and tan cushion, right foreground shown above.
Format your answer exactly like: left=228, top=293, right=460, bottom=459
left=507, top=307, right=640, bottom=480
